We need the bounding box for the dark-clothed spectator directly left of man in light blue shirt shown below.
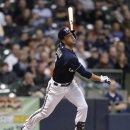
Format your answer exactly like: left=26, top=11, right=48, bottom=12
left=15, top=9, right=31, bottom=26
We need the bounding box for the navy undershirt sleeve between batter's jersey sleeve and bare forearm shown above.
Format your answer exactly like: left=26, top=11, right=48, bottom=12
left=77, top=65, right=92, bottom=79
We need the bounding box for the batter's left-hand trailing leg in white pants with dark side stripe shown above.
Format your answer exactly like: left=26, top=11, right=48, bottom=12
left=22, top=79, right=64, bottom=130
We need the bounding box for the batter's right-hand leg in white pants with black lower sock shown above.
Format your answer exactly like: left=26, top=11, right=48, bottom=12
left=65, top=80, right=88, bottom=130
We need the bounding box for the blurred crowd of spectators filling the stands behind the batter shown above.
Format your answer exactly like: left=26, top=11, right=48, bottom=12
left=0, top=0, right=130, bottom=97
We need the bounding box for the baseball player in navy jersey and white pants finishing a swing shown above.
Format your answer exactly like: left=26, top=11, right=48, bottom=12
left=21, top=27, right=111, bottom=130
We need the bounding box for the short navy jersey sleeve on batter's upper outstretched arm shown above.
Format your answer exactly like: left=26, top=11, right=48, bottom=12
left=68, top=57, right=81, bottom=72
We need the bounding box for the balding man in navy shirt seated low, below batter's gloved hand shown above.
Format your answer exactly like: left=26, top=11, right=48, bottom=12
left=105, top=80, right=126, bottom=112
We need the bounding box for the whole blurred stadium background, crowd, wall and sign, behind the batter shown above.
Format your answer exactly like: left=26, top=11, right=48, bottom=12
left=0, top=0, right=130, bottom=130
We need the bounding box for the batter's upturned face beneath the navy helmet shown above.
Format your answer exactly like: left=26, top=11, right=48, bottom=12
left=63, top=33, right=76, bottom=46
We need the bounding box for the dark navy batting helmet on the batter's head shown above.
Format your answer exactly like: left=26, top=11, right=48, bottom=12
left=58, top=27, right=76, bottom=40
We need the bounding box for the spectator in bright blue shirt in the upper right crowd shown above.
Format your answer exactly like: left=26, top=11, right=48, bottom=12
left=111, top=22, right=123, bottom=39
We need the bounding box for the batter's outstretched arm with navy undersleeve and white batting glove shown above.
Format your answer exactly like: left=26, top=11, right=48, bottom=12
left=77, top=65, right=111, bottom=84
